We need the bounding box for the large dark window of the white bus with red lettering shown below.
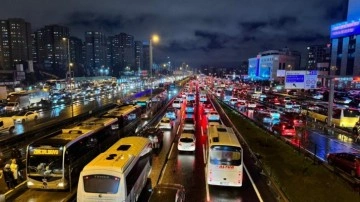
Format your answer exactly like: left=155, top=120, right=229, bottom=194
left=209, top=145, right=241, bottom=166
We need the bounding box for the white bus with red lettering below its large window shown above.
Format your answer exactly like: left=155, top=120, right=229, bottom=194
left=206, top=125, right=244, bottom=187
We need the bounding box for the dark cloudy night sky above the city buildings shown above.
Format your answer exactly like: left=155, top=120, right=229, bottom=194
left=0, top=0, right=345, bottom=67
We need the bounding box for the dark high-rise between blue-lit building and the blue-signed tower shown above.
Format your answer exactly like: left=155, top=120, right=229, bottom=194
left=306, top=44, right=331, bottom=71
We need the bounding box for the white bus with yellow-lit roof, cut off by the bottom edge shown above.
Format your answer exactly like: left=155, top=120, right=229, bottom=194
left=77, top=137, right=151, bottom=202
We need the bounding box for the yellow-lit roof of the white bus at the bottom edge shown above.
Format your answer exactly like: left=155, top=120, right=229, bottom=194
left=83, top=137, right=151, bottom=173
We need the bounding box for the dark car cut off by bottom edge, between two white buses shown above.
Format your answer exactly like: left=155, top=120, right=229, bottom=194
left=148, top=183, right=185, bottom=202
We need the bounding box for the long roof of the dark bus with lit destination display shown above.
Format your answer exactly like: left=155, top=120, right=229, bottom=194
left=31, top=117, right=117, bottom=147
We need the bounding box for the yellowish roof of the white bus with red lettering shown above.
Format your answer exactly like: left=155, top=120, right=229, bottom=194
left=208, top=125, right=241, bottom=147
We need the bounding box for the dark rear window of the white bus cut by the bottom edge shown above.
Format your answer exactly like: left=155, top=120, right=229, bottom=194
left=83, top=175, right=120, bottom=194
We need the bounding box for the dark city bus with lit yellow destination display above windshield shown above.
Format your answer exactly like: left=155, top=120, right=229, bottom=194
left=26, top=117, right=118, bottom=190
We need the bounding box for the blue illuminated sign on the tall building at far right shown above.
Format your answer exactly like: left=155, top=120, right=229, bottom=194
left=330, top=21, right=360, bottom=39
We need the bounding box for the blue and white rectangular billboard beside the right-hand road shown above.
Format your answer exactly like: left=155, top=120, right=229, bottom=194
left=285, top=70, right=317, bottom=89
